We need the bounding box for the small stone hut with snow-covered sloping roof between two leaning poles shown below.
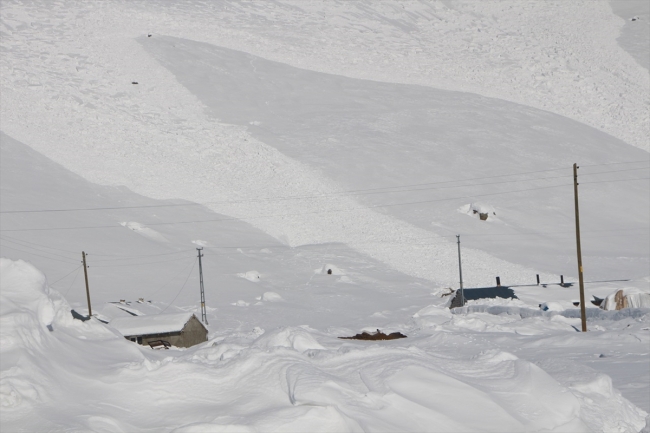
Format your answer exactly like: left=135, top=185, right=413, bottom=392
left=110, top=313, right=208, bottom=347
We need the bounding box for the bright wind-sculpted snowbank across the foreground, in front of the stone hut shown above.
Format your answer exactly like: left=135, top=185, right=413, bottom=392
left=0, top=259, right=647, bottom=432
